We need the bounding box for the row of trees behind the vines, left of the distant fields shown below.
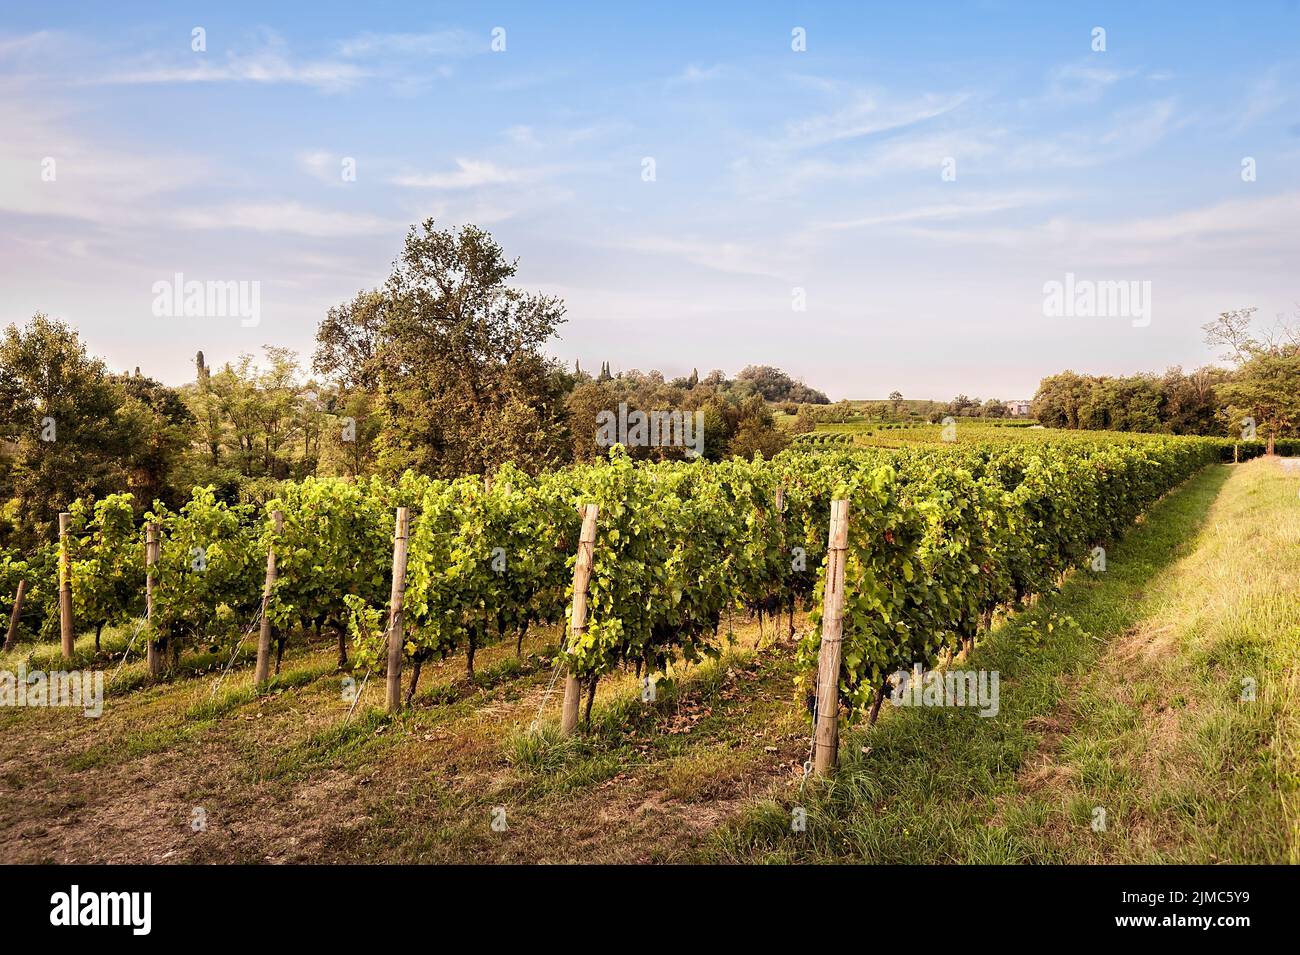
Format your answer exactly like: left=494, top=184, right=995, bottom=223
left=0, top=220, right=811, bottom=546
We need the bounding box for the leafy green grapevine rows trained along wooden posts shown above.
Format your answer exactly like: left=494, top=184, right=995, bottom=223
left=0, top=429, right=1234, bottom=753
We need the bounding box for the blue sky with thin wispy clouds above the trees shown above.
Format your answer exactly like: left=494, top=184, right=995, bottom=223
left=0, top=0, right=1300, bottom=400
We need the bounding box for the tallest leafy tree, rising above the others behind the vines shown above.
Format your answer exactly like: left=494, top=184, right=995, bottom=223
left=316, top=218, right=569, bottom=476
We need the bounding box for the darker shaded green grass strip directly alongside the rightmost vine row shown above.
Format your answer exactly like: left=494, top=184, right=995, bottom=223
left=706, top=466, right=1231, bottom=863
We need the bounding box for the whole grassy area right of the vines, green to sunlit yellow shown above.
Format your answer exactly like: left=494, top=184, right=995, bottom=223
left=707, top=461, right=1300, bottom=863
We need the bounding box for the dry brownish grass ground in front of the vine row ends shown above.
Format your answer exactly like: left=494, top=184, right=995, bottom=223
left=0, top=613, right=807, bottom=863
